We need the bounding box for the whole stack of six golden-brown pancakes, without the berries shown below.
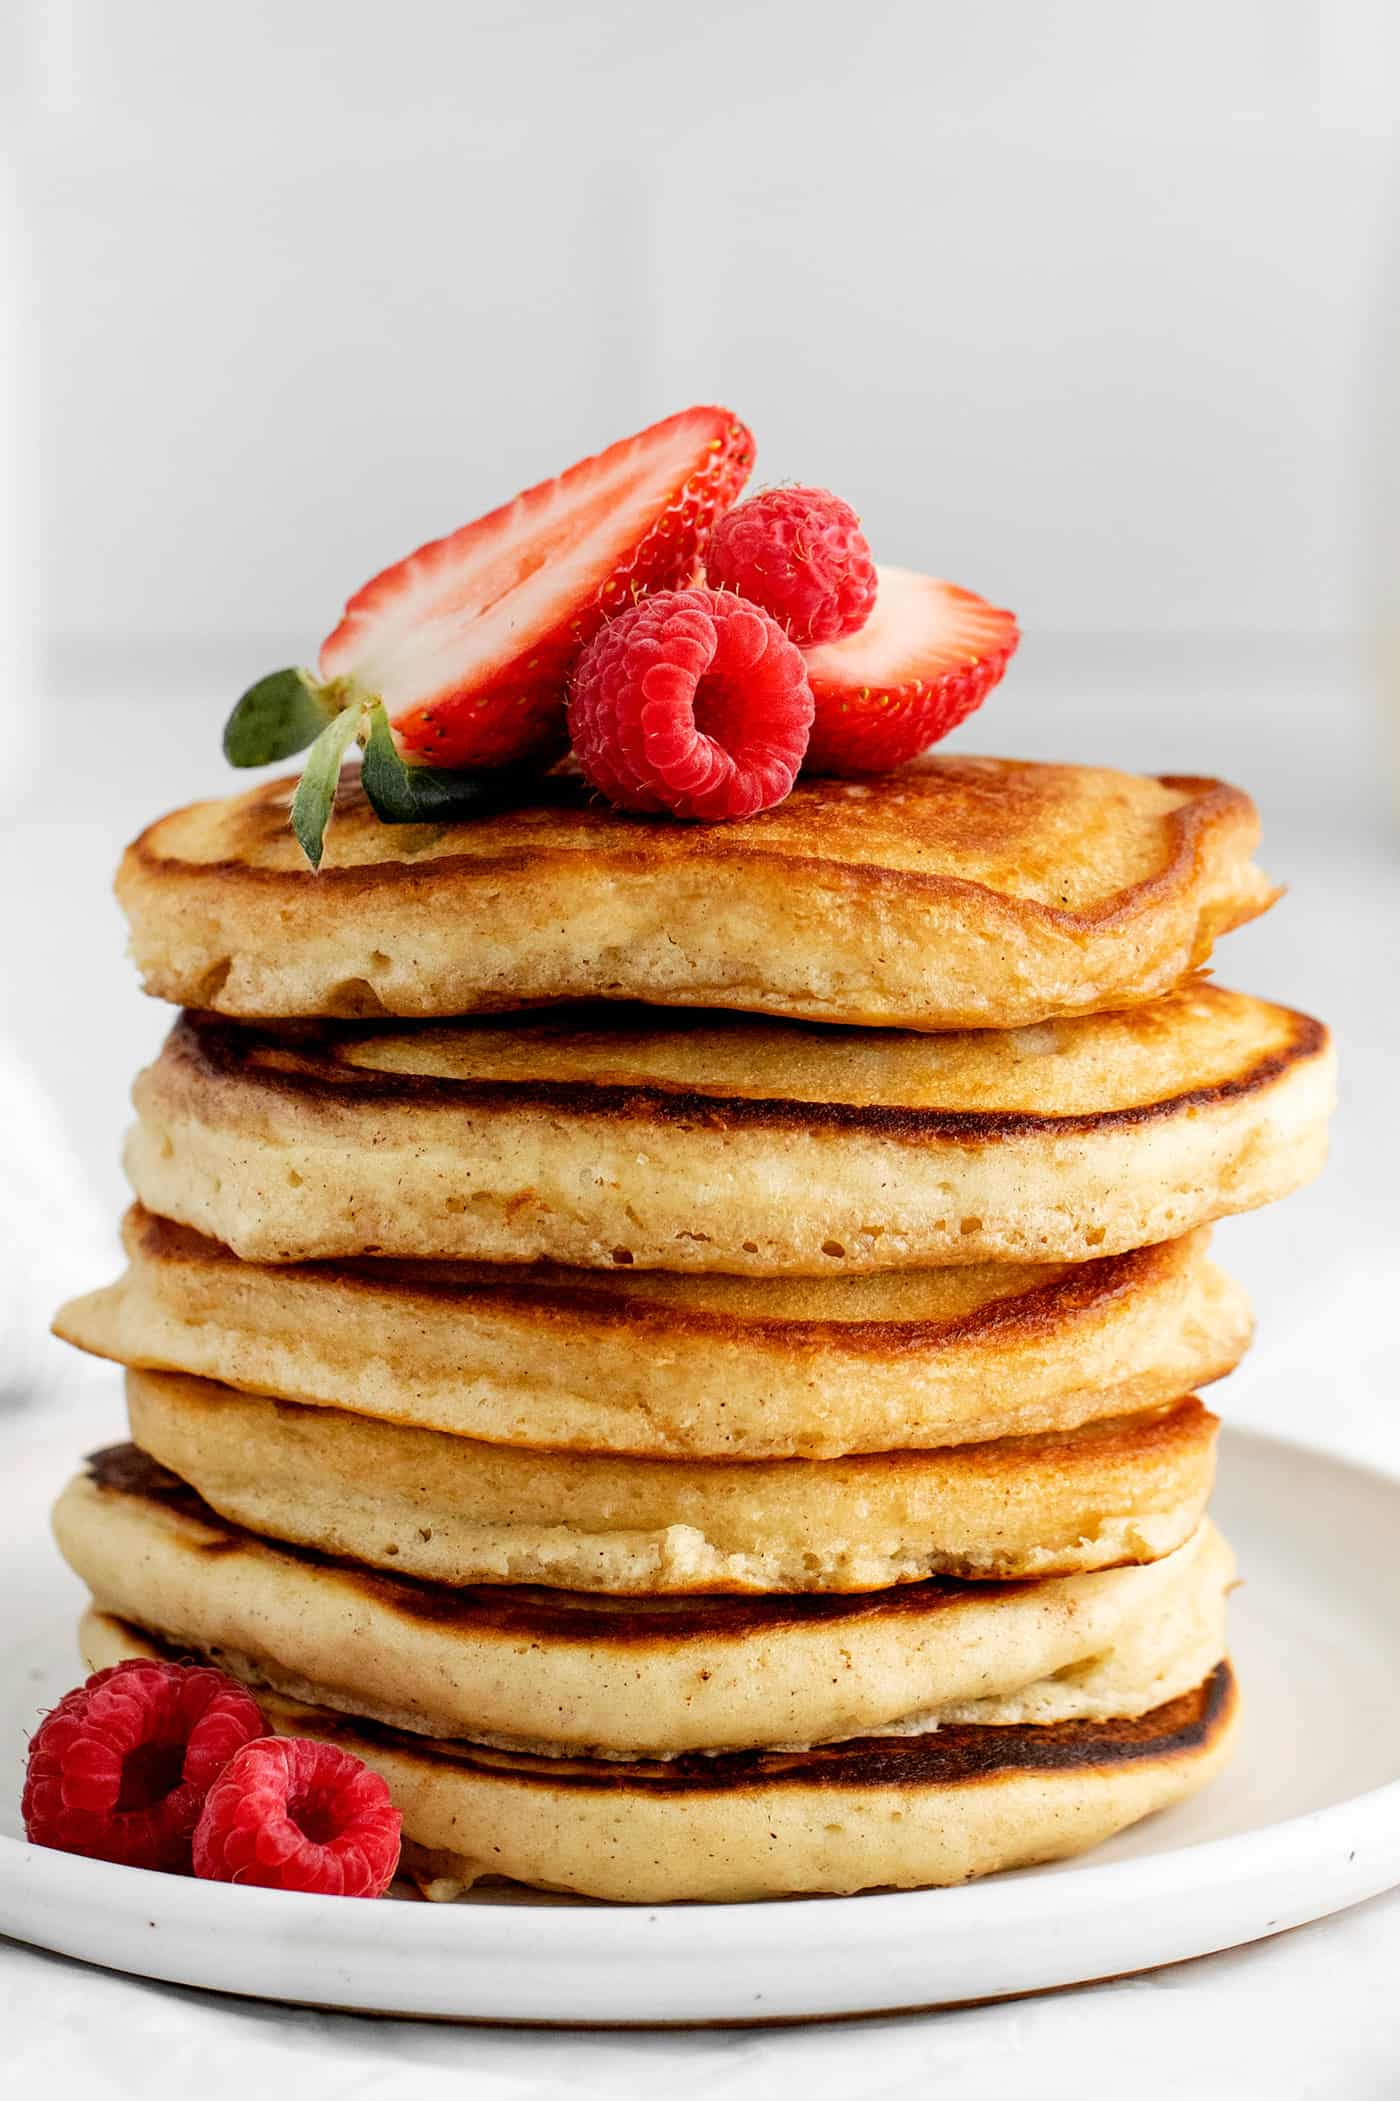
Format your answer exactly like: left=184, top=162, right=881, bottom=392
left=46, top=758, right=1333, bottom=1901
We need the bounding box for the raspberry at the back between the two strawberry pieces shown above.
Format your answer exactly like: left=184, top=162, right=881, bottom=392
left=704, top=490, right=874, bottom=649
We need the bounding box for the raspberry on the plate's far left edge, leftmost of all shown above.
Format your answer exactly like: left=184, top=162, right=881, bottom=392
left=23, top=1658, right=267, bottom=1874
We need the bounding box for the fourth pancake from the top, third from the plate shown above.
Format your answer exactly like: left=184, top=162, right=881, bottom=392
left=126, top=1372, right=1217, bottom=1595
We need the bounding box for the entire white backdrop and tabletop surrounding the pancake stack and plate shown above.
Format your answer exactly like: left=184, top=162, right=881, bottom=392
left=0, top=0, right=1400, bottom=2101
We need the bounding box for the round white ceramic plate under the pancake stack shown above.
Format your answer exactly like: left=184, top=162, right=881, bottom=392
left=0, top=1418, right=1400, bottom=2023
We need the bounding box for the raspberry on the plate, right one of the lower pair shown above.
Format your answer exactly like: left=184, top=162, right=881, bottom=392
left=193, top=1735, right=399, bottom=1897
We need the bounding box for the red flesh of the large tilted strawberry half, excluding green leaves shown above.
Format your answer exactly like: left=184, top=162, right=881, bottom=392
left=320, top=408, right=755, bottom=767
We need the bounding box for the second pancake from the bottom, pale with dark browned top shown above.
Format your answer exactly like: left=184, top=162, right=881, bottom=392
left=55, top=1445, right=1234, bottom=1756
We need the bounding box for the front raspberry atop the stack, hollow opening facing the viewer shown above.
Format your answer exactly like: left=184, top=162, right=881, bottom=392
left=570, top=588, right=811, bottom=824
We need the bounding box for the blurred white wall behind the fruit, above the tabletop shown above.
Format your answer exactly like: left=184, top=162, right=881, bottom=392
left=0, top=0, right=1400, bottom=653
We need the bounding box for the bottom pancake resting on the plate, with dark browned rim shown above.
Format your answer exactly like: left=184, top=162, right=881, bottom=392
left=80, top=1614, right=1238, bottom=1904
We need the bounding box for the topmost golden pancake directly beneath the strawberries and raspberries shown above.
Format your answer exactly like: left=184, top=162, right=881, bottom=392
left=118, top=756, right=1276, bottom=1029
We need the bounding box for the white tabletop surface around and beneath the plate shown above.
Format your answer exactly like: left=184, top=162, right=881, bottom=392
left=0, top=651, right=1400, bottom=2101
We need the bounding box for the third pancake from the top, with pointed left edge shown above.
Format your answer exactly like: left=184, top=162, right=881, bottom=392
left=55, top=1208, right=1249, bottom=1458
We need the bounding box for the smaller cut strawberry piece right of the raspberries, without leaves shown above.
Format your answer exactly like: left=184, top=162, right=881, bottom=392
left=803, top=569, right=1022, bottom=773
